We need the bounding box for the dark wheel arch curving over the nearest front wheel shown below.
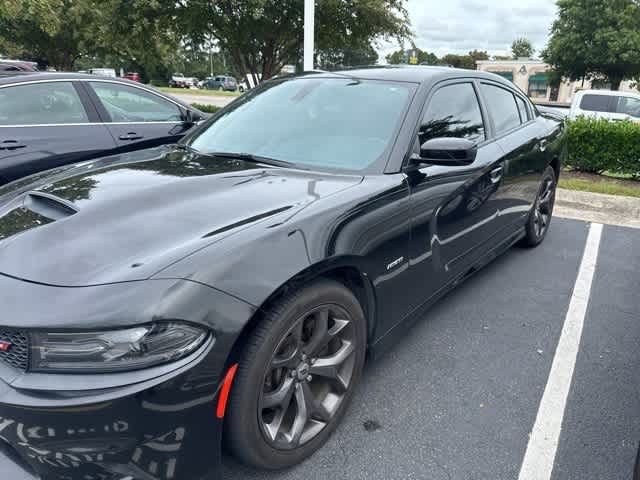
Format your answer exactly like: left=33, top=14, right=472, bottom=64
left=229, top=256, right=376, bottom=359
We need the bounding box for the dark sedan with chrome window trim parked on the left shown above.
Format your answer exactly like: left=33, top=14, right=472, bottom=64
left=0, top=72, right=208, bottom=185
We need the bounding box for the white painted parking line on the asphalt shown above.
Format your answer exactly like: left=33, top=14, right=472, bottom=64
left=518, top=223, right=602, bottom=480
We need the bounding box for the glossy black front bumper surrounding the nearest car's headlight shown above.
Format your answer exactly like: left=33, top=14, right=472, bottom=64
left=0, top=275, right=255, bottom=480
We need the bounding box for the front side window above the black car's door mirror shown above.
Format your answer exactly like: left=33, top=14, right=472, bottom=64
left=418, top=83, right=485, bottom=144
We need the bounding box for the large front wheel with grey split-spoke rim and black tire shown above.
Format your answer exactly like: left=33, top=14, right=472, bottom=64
left=225, top=280, right=366, bottom=470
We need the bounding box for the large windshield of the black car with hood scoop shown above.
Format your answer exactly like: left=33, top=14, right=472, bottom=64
left=189, top=77, right=415, bottom=171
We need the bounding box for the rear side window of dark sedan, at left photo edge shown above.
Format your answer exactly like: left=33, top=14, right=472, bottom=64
left=0, top=82, right=89, bottom=125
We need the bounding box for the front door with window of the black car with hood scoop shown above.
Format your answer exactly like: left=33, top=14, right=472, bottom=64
left=407, top=81, right=503, bottom=307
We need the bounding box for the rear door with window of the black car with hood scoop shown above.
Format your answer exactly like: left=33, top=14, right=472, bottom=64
left=480, top=81, right=549, bottom=235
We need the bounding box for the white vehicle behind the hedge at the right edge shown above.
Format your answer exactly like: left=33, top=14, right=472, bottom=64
left=569, top=90, right=640, bottom=122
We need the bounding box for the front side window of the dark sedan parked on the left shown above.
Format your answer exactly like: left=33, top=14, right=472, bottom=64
left=91, top=82, right=182, bottom=122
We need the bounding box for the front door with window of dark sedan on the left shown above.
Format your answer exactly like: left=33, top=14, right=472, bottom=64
left=86, top=81, right=192, bottom=151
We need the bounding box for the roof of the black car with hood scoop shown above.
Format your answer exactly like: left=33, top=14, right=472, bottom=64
left=308, top=65, right=514, bottom=88
